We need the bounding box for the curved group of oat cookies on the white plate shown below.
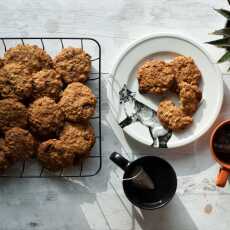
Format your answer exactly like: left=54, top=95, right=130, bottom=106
left=138, top=56, right=202, bottom=131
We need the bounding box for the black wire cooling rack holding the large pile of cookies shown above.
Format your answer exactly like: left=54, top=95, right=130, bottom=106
left=0, top=37, right=102, bottom=178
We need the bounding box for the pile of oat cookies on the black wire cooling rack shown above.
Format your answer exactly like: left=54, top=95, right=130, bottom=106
left=0, top=45, right=96, bottom=171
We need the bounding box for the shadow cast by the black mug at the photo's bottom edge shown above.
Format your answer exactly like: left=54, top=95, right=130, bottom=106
left=132, top=195, right=198, bottom=230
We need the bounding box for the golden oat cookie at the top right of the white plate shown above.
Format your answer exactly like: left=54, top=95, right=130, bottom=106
left=170, top=56, right=201, bottom=92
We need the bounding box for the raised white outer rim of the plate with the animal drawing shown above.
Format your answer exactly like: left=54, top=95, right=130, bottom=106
left=107, top=32, right=224, bottom=149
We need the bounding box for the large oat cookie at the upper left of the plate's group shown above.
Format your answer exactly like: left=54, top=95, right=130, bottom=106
left=137, top=60, right=174, bottom=95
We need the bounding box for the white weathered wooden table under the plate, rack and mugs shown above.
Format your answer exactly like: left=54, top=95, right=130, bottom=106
left=0, top=0, right=230, bottom=230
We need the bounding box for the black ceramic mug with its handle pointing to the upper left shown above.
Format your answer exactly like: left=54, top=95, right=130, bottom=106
left=110, top=152, right=177, bottom=210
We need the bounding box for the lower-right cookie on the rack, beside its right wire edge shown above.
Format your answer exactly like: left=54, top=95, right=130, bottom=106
left=60, top=123, right=95, bottom=157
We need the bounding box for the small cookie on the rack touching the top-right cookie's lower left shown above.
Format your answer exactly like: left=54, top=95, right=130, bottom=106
left=32, top=69, right=63, bottom=100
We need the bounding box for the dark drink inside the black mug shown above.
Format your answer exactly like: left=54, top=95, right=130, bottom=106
left=123, top=157, right=176, bottom=206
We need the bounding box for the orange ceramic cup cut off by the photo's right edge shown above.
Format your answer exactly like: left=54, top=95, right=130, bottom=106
left=210, top=119, right=230, bottom=187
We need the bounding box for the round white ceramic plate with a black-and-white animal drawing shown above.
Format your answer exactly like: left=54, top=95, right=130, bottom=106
left=109, top=34, right=223, bottom=148
